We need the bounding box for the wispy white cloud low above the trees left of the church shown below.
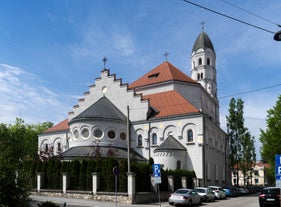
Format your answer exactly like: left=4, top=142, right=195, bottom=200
left=0, top=64, right=67, bottom=123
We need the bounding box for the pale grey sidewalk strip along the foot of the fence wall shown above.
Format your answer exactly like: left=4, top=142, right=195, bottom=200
left=30, top=195, right=169, bottom=207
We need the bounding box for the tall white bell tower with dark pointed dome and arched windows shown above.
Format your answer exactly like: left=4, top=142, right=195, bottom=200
left=191, top=25, right=217, bottom=99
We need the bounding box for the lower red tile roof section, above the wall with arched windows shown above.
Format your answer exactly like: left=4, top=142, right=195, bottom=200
left=143, top=90, right=199, bottom=117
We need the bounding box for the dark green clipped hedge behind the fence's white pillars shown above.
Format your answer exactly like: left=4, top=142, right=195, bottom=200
left=20, top=158, right=195, bottom=192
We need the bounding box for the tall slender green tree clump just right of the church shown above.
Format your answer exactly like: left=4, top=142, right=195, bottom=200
left=226, top=98, right=256, bottom=185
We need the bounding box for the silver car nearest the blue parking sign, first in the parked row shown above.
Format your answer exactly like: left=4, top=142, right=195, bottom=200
left=169, top=188, right=202, bottom=206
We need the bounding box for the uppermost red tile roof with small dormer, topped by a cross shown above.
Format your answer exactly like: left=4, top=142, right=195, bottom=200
left=129, top=61, right=197, bottom=89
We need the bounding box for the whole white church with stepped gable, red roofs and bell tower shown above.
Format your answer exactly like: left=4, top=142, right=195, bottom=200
left=38, top=29, right=229, bottom=186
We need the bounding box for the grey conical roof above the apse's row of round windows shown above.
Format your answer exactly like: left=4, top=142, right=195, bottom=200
left=69, top=96, right=127, bottom=124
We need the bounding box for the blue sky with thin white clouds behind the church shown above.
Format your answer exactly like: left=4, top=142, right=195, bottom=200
left=0, top=0, right=281, bottom=158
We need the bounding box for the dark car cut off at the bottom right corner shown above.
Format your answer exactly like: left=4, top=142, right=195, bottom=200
left=259, top=187, right=280, bottom=207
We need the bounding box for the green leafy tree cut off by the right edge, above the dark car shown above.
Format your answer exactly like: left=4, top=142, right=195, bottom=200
left=260, top=95, right=281, bottom=183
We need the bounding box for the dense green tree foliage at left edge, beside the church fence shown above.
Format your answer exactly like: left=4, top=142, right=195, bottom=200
left=0, top=119, right=53, bottom=207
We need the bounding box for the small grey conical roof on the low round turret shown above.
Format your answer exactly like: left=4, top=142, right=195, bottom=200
left=154, top=135, right=186, bottom=152
